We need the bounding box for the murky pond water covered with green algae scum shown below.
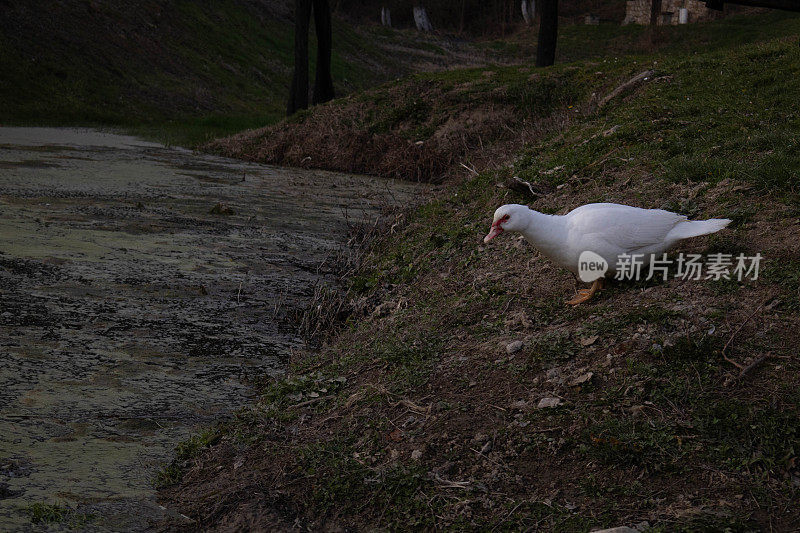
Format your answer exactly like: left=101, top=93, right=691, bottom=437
left=0, top=128, right=417, bottom=530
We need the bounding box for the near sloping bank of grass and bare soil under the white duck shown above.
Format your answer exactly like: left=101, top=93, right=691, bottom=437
left=158, top=14, right=800, bottom=531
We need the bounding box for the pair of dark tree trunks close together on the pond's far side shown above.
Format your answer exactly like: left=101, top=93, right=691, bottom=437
left=286, top=0, right=334, bottom=115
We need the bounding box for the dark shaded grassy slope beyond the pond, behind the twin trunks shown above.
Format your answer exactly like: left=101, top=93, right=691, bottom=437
left=0, top=0, right=401, bottom=144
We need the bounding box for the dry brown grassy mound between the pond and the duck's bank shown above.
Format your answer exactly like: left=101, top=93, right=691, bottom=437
left=204, top=61, right=612, bottom=181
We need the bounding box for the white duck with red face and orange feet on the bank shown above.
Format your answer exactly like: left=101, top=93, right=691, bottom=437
left=483, top=204, right=730, bottom=305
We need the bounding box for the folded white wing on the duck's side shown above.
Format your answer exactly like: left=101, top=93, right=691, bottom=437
left=569, top=204, right=686, bottom=254
